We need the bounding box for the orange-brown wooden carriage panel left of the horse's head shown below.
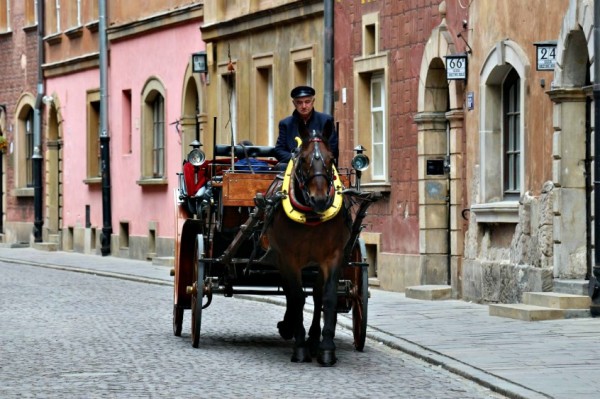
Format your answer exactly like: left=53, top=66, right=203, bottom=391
left=222, top=173, right=276, bottom=206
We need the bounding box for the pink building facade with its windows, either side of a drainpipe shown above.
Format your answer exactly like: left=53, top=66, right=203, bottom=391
left=45, top=4, right=204, bottom=259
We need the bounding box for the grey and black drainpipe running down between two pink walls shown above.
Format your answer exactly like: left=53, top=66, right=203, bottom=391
left=98, top=0, right=112, bottom=256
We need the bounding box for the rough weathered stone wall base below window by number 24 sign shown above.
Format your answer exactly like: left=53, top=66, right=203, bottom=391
left=462, top=170, right=556, bottom=303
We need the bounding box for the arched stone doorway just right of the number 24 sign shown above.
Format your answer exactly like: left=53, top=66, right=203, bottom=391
left=548, top=1, right=593, bottom=282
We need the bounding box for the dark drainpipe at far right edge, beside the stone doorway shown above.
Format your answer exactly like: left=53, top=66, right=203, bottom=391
left=589, top=1, right=600, bottom=317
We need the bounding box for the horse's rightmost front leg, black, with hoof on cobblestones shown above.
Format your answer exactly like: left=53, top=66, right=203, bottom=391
left=317, top=270, right=338, bottom=366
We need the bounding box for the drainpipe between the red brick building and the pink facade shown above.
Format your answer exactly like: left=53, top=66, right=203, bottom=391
left=31, top=1, right=44, bottom=242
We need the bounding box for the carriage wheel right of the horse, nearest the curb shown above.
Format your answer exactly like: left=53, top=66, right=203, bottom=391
left=352, top=240, right=369, bottom=352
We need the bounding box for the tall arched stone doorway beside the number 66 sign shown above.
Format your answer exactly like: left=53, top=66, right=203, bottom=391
left=415, top=8, right=464, bottom=297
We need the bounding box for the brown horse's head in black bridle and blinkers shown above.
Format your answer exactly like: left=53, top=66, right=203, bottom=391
left=294, top=121, right=335, bottom=212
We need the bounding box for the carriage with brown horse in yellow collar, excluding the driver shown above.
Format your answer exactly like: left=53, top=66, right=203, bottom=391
left=173, top=122, right=377, bottom=365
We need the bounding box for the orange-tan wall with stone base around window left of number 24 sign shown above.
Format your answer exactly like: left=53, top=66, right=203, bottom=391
left=462, top=0, right=573, bottom=303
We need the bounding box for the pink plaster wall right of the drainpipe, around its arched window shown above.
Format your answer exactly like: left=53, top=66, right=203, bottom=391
left=109, top=23, right=202, bottom=238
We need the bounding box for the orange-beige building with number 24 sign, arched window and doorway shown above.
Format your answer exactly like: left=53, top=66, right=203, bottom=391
left=462, top=0, right=593, bottom=303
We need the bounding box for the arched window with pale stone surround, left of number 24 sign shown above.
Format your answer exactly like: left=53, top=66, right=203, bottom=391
left=471, top=40, right=530, bottom=223
